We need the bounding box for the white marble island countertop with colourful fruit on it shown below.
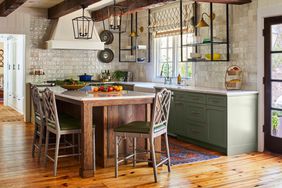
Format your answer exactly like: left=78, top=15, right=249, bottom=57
left=50, top=86, right=155, bottom=101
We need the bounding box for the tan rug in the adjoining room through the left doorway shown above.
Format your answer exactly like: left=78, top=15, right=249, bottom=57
left=0, top=105, right=23, bottom=123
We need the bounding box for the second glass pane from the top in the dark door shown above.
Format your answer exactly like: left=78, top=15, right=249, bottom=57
left=271, top=53, right=282, bottom=80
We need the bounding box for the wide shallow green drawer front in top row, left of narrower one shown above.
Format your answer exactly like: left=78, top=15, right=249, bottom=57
left=174, top=92, right=206, bottom=104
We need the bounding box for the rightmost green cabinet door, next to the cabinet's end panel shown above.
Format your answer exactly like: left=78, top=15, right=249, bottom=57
left=207, top=106, right=227, bottom=148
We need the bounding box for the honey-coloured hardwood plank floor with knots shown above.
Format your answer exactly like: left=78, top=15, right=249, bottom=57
left=0, top=122, right=282, bottom=188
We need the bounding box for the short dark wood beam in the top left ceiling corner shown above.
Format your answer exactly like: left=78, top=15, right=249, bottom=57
left=0, top=0, right=26, bottom=17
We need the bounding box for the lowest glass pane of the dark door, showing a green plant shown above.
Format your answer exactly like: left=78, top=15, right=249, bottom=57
left=271, top=110, right=282, bottom=138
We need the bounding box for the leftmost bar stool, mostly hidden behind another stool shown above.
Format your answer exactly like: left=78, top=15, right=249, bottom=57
left=31, top=86, right=45, bottom=161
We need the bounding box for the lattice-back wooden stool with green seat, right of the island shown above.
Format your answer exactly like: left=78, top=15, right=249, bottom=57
left=114, top=89, right=171, bottom=182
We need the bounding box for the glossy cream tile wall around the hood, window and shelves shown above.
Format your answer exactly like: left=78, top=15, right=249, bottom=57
left=14, top=0, right=257, bottom=89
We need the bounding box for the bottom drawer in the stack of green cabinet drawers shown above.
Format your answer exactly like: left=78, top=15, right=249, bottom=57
left=187, top=123, right=208, bottom=142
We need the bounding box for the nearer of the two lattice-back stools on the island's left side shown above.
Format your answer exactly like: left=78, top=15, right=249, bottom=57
left=42, top=88, right=96, bottom=176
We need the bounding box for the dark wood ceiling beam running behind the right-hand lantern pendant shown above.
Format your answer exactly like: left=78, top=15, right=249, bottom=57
left=91, top=0, right=175, bottom=22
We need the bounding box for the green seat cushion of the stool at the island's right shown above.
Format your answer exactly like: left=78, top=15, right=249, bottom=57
left=114, top=121, right=166, bottom=134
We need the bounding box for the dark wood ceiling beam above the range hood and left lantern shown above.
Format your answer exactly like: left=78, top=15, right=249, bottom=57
left=48, top=0, right=100, bottom=19
